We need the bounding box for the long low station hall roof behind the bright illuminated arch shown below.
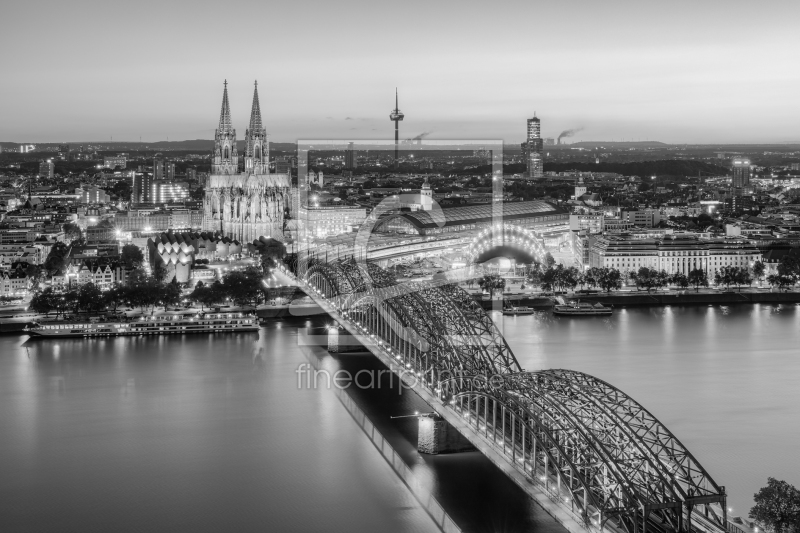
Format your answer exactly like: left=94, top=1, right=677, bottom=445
left=382, top=200, right=567, bottom=229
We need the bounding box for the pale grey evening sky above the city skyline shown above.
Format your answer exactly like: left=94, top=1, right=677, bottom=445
left=0, top=0, right=800, bottom=143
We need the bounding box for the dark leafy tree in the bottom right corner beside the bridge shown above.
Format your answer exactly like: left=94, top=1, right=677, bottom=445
left=750, top=477, right=800, bottom=533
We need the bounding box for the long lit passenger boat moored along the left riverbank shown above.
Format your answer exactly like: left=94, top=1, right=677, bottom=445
left=24, top=313, right=259, bottom=338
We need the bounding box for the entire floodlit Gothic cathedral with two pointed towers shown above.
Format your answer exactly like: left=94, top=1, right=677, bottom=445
left=203, top=81, right=292, bottom=243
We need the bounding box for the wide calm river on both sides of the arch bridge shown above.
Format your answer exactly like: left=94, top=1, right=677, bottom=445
left=0, top=305, right=800, bottom=533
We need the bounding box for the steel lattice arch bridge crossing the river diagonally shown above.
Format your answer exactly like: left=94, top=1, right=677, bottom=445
left=298, top=259, right=727, bottom=533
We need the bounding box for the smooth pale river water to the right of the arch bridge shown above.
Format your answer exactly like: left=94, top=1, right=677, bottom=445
left=494, top=304, right=800, bottom=515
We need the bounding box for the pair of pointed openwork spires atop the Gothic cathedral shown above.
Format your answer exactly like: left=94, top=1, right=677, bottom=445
left=212, top=80, right=269, bottom=174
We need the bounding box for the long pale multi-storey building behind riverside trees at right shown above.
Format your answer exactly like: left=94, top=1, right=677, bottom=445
left=589, top=235, right=761, bottom=279
